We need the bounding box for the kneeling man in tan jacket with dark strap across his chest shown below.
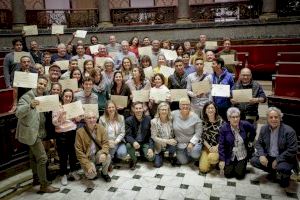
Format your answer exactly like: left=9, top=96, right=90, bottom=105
left=75, top=112, right=111, bottom=182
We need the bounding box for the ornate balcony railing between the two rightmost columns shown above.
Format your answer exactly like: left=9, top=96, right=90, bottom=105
left=190, top=1, right=260, bottom=22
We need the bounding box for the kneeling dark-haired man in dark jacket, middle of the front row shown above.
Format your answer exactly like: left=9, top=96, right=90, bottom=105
left=125, top=102, right=154, bottom=170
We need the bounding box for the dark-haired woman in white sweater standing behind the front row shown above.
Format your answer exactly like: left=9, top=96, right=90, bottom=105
left=149, top=73, right=171, bottom=116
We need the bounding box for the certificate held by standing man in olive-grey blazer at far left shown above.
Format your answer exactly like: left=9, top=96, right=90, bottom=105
left=35, top=94, right=60, bottom=112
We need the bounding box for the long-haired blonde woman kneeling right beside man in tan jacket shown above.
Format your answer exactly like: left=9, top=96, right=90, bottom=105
left=99, top=101, right=127, bottom=171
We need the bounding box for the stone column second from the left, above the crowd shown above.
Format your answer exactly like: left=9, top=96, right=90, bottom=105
left=98, top=0, right=113, bottom=27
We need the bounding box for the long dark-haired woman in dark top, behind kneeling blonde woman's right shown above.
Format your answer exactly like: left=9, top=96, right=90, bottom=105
left=110, top=71, right=130, bottom=119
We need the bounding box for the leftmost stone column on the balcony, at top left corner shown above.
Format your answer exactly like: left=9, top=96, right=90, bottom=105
left=11, top=0, right=26, bottom=30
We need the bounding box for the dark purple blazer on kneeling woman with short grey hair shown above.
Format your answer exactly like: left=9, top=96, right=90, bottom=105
left=219, top=120, right=256, bottom=165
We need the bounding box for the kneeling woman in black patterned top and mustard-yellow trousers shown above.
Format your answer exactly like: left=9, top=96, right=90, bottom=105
left=199, top=101, right=223, bottom=173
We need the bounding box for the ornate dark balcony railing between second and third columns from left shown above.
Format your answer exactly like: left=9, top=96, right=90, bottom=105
left=110, top=6, right=177, bottom=26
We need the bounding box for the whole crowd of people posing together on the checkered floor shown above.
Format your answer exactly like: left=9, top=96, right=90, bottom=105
left=4, top=35, right=298, bottom=192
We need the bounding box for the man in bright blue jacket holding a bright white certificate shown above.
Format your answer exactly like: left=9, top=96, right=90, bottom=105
left=211, top=58, right=234, bottom=121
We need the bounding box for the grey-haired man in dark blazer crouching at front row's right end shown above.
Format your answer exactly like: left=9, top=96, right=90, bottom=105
left=250, top=107, right=298, bottom=187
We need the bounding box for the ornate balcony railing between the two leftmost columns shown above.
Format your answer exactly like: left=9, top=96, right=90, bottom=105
left=26, top=9, right=98, bottom=28
